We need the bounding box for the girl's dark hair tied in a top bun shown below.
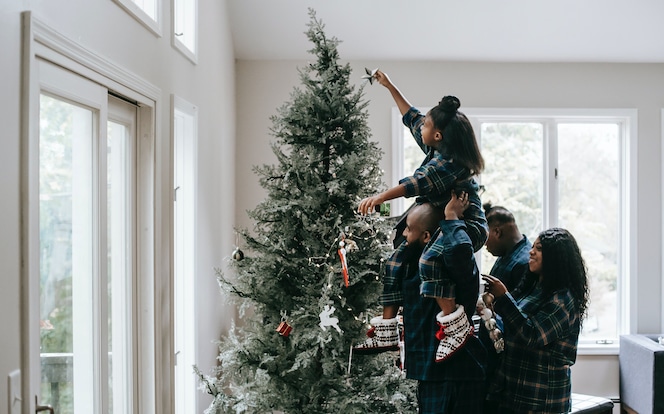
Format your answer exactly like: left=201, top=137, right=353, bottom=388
left=428, top=95, right=484, bottom=175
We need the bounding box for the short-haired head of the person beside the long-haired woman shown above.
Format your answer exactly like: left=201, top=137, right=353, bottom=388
left=484, top=203, right=523, bottom=257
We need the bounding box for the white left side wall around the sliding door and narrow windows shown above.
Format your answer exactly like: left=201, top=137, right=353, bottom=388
left=0, top=0, right=235, bottom=412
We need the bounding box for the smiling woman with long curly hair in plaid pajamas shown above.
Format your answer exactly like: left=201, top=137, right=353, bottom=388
left=484, top=228, right=588, bottom=414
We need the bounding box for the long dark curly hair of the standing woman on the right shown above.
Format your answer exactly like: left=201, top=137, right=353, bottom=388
left=538, top=227, right=589, bottom=320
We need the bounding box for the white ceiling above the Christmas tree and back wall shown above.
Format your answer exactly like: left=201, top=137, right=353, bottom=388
left=227, top=0, right=664, bottom=63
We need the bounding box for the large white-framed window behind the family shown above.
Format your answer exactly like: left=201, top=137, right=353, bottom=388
left=393, top=108, right=636, bottom=353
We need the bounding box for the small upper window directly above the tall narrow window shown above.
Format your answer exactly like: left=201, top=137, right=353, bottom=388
left=173, top=0, right=198, bottom=63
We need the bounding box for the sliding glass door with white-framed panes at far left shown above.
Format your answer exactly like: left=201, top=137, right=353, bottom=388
left=39, top=62, right=136, bottom=413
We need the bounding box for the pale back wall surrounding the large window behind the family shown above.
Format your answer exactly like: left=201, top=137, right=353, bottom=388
left=236, top=61, right=664, bottom=397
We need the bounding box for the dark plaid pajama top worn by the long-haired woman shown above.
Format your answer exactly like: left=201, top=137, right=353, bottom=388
left=490, top=276, right=581, bottom=413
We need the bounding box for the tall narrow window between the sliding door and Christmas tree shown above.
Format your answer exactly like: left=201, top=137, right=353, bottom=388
left=173, top=97, right=198, bottom=414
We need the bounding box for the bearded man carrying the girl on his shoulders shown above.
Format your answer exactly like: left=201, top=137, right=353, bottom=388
left=402, top=201, right=486, bottom=414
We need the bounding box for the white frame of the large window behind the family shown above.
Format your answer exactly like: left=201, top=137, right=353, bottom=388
left=392, top=107, right=636, bottom=355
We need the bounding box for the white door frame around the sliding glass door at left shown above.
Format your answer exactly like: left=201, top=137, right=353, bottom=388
left=20, top=11, right=174, bottom=414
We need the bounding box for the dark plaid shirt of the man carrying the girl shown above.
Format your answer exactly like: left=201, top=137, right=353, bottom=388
left=399, top=220, right=486, bottom=381
